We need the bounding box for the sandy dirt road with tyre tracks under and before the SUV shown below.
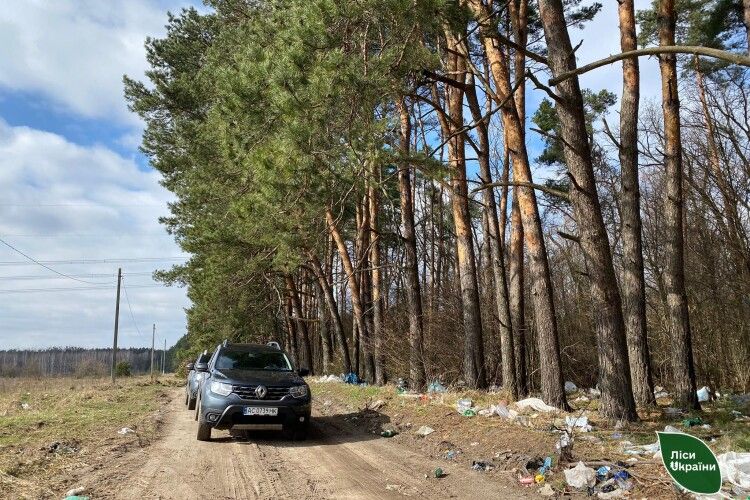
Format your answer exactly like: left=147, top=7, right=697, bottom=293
left=91, top=392, right=532, bottom=499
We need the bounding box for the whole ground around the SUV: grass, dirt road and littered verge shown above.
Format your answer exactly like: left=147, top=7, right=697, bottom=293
left=0, top=377, right=750, bottom=499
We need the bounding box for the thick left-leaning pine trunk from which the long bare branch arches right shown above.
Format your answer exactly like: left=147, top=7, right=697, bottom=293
left=539, top=0, right=638, bottom=421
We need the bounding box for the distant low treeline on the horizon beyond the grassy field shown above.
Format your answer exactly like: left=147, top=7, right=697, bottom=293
left=0, top=347, right=172, bottom=377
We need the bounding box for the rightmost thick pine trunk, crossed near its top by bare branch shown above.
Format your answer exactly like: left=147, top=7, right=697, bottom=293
left=659, top=0, right=700, bottom=410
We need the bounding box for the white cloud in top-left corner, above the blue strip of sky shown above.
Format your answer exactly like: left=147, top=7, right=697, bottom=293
left=0, top=0, right=188, bottom=124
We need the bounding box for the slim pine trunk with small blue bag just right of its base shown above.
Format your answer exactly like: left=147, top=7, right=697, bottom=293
left=398, top=98, right=434, bottom=390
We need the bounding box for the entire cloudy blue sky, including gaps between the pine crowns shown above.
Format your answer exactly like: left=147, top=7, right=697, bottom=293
left=0, top=0, right=659, bottom=349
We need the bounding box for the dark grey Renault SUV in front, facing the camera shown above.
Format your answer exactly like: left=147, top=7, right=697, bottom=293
left=195, top=341, right=311, bottom=441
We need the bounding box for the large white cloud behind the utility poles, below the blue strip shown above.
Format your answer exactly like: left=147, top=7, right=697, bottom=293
left=0, top=120, right=188, bottom=348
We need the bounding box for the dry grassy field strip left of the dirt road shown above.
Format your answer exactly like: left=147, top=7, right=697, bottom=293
left=0, top=377, right=175, bottom=498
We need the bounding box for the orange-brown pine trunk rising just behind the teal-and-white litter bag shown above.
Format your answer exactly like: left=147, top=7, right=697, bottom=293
left=444, top=30, right=486, bottom=388
